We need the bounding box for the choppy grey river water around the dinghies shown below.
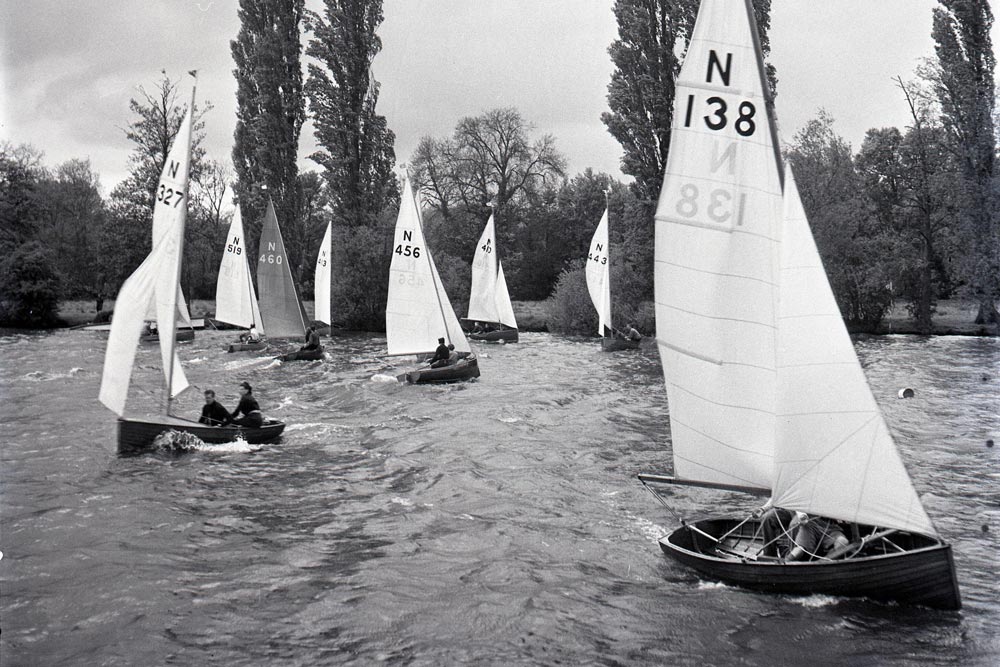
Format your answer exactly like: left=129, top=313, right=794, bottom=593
left=0, top=331, right=1000, bottom=665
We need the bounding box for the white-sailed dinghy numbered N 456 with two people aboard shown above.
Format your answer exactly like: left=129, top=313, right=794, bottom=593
left=385, top=177, right=479, bottom=384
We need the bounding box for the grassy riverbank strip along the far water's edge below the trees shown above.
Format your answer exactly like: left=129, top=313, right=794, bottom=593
left=59, top=299, right=998, bottom=336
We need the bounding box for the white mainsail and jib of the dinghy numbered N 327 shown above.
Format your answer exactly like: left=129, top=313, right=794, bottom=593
left=100, top=100, right=194, bottom=415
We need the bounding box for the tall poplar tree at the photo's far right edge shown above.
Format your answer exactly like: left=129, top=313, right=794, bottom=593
left=931, top=0, right=1000, bottom=324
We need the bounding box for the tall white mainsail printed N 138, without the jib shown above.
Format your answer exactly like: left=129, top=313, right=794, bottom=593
left=654, top=0, right=781, bottom=489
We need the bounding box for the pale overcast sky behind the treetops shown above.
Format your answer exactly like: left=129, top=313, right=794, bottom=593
left=0, top=0, right=1000, bottom=191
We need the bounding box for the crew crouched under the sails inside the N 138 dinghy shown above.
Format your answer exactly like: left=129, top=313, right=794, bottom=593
left=761, top=507, right=850, bottom=560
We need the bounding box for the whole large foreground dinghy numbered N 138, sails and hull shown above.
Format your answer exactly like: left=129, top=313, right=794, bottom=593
left=639, top=0, right=961, bottom=609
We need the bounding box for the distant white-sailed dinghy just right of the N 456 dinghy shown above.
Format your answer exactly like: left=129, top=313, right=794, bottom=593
left=462, top=215, right=517, bottom=343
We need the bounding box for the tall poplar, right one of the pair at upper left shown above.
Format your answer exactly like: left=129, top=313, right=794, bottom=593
left=306, top=0, right=399, bottom=226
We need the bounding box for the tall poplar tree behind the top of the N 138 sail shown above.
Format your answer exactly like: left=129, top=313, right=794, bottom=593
left=601, top=0, right=775, bottom=201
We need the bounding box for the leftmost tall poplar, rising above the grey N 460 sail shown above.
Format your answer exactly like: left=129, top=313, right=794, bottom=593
left=230, top=0, right=306, bottom=262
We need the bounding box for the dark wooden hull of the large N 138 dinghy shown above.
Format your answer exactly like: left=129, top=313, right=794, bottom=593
left=660, top=519, right=962, bottom=609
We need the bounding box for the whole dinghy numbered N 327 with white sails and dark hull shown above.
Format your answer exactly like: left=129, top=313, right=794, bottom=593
left=100, top=91, right=285, bottom=454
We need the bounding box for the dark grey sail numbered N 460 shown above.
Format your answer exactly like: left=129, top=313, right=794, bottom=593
left=257, top=200, right=306, bottom=338
